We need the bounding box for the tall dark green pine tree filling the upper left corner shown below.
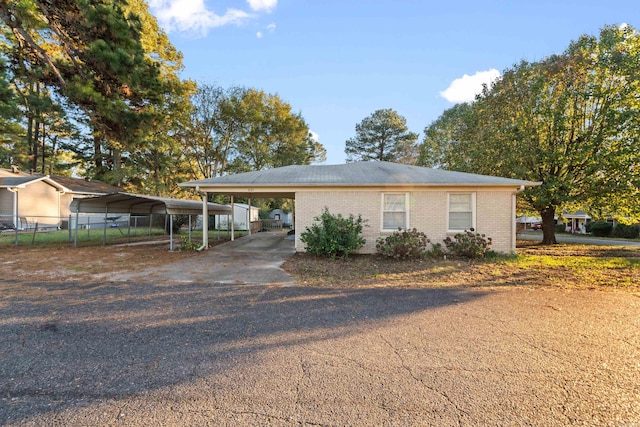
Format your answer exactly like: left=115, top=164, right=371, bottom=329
left=0, top=0, right=162, bottom=182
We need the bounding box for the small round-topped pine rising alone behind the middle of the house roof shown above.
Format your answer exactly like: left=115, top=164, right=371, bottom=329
left=344, top=108, right=418, bottom=164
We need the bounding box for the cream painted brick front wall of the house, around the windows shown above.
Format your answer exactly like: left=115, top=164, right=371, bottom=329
left=295, top=189, right=515, bottom=253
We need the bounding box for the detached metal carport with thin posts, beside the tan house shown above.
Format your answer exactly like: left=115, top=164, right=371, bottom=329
left=71, top=193, right=232, bottom=250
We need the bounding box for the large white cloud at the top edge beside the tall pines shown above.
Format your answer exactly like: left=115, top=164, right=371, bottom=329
left=149, top=0, right=251, bottom=36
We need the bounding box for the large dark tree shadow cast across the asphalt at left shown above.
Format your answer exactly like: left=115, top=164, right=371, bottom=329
left=0, top=282, right=484, bottom=424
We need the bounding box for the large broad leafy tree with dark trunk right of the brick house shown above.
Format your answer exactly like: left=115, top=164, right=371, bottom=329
left=423, top=26, right=640, bottom=244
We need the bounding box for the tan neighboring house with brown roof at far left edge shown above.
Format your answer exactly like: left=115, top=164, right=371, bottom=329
left=0, top=168, right=120, bottom=230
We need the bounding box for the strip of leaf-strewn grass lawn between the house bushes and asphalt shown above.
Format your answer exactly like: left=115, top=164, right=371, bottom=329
left=283, top=241, right=640, bottom=292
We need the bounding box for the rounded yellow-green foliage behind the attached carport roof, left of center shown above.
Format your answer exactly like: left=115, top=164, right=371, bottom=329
left=184, top=84, right=326, bottom=179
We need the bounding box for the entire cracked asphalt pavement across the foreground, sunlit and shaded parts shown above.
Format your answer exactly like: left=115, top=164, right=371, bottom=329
left=0, top=279, right=640, bottom=426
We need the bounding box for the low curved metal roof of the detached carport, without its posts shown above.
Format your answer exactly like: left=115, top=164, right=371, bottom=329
left=71, top=193, right=231, bottom=215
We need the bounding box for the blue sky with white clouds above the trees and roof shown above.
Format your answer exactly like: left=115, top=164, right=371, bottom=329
left=148, top=0, right=640, bottom=164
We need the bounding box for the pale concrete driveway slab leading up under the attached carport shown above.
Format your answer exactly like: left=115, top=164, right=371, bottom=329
left=110, top=231, right=295, bottom=286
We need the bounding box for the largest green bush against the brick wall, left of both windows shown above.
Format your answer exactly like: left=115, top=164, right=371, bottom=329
left=300, top=208, right=366, bottom=259
